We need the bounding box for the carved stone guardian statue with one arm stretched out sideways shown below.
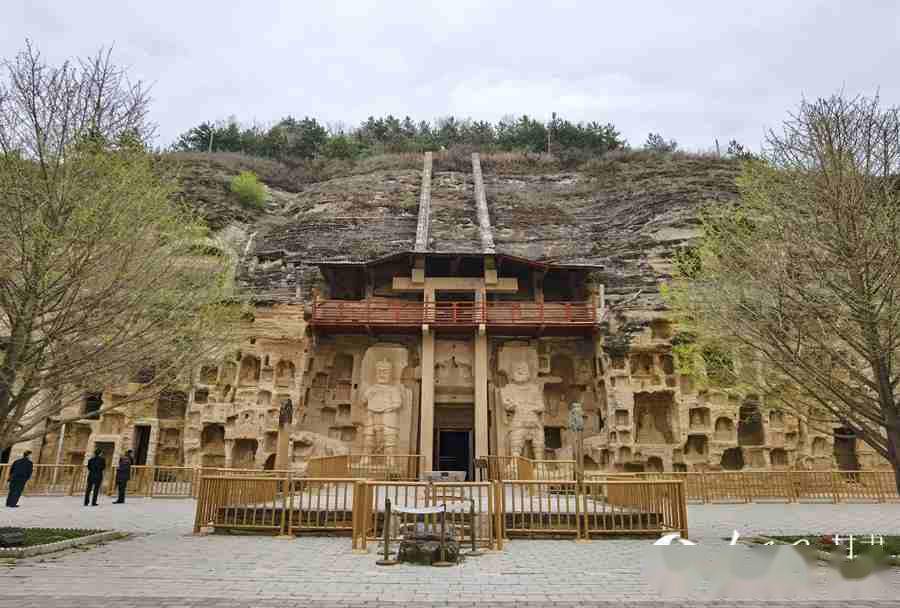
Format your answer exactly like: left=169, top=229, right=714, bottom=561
left=500, top=361, right=560, bottom=458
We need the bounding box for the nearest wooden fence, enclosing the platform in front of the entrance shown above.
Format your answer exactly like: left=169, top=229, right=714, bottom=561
left=194, top=475, right=688, bottom=549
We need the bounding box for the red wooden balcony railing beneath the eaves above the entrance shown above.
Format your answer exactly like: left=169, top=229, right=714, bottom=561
left=312, top=300, right=597, bottom=328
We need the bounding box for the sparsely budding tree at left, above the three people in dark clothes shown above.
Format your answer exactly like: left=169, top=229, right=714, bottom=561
left=0, top=43, right=239, bottom=449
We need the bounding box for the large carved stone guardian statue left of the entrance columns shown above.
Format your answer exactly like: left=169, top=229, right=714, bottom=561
left=363, top=359, right=403, bottom=454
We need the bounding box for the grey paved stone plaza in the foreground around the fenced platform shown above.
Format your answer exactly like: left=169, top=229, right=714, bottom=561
left=0, top=497, right=900, bottom=608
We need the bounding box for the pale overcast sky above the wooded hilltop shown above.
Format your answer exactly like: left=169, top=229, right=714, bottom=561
left=0, top=0, right=900, bottom=149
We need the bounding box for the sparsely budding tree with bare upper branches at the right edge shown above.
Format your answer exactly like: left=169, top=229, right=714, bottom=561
left=671, top=95, right=900, bottom=489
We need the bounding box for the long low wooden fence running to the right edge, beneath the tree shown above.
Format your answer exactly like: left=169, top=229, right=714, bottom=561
left=586, top=470, right=900, bottom=504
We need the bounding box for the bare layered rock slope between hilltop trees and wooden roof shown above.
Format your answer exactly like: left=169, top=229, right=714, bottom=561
left=171, top=152, right=739, bottom=309
